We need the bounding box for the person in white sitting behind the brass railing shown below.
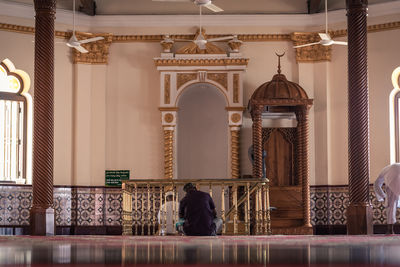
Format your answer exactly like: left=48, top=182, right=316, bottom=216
left=157, top=191, right=179, bottom=235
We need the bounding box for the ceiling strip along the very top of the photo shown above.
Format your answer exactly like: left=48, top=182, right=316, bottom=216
left=4, top=0, right=400, bottom=15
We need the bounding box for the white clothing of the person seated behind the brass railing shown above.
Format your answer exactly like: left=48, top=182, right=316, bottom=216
left=157, top=201, right=179, bottom=235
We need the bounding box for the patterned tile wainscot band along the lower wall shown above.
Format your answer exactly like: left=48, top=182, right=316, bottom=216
left=0, top=186, right=388, bottom=230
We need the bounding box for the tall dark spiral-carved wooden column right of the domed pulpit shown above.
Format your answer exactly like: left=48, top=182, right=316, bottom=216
left=346, top=0, right=372, bottom=234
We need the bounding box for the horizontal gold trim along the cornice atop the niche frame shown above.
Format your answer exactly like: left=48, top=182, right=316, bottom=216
left=154, top=58, right=249, bottom=66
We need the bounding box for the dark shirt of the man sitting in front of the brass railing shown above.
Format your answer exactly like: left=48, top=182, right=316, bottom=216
left=179, top=190, right=215, bottom=236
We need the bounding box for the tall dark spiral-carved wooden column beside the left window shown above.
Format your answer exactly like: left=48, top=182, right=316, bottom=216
left=30, top=0, right=56, bottom=235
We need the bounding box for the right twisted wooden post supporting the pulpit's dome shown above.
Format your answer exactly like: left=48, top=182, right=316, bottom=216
left=296, top=106, right=311, bottom=227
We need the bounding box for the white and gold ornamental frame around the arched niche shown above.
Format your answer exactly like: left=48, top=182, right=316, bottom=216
left=154, top=53, right=248, bottom=179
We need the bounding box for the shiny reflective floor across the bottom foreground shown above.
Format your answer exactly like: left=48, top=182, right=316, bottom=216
left=0, top=235, right=400, bottom=267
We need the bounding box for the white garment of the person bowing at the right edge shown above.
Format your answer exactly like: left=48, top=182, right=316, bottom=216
left=374, top=163, right=400, bottom=224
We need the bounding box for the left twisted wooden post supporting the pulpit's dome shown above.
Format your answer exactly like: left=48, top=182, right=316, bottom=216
left=251, top=105, right=263, bottom=178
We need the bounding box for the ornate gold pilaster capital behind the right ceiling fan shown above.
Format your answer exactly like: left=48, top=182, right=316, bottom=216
left=291, top=32, right=332, bottom=62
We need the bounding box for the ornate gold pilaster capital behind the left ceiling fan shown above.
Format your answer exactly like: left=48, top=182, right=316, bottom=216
left=72, top=32, right=112, bottom=64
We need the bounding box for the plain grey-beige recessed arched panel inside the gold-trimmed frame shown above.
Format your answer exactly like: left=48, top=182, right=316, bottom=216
left=177, top=83, right=229, bottom=179
